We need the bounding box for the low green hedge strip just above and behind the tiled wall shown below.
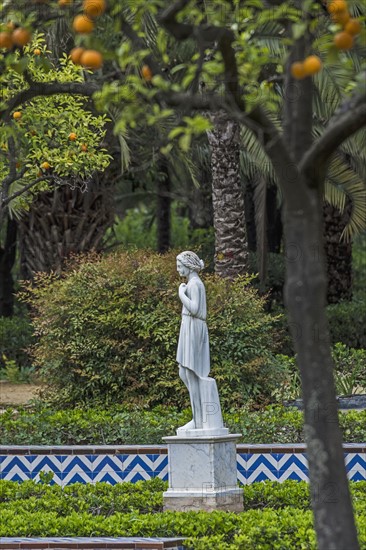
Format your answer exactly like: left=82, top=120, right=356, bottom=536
left=0, top=406, right=366, bottom=445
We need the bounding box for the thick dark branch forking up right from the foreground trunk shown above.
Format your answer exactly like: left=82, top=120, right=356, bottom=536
left=300, top=94, right=366, bottom=176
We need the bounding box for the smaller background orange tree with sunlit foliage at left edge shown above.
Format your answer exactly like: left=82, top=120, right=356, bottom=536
left=0, top=35, right=110, bottom=316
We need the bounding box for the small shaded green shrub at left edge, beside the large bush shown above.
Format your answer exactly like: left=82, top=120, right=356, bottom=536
left=0, top=317, right=34, bottom=368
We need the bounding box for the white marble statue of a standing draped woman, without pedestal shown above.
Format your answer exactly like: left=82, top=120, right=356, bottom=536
left=177, top=251, right=228, bottom=436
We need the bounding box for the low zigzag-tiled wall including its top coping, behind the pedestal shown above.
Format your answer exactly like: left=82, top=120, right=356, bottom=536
left=0, top=444, right=366, bottom=486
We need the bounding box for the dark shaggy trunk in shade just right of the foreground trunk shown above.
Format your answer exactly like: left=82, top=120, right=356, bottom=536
left=323, top=202, right=352, bottom=304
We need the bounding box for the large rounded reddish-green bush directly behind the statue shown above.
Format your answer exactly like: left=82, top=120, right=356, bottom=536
left=22, top=251, right=284, bottom=406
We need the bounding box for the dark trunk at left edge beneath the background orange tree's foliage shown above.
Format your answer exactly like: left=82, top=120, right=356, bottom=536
left=0, top=218, right=17, bottom=317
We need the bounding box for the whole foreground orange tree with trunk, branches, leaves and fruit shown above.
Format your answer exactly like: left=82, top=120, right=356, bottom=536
left=0, top=0, right=366, bottom=550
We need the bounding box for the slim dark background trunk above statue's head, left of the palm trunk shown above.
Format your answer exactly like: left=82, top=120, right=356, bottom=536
left=156, top=161, right=171, bottom=253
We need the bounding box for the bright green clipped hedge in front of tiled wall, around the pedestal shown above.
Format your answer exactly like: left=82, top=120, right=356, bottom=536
left=0, top=479, right=366, bottom=550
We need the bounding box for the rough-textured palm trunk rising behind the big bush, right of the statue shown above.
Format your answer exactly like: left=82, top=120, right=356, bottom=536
left=208, top=114, right=248, bottom=278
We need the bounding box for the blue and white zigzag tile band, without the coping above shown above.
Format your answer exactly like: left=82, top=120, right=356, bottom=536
left=0, top=451, right=366, bottom=486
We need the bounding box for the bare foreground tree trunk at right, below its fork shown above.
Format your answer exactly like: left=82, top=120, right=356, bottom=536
left=285, top=187, right=358, bottom=550
